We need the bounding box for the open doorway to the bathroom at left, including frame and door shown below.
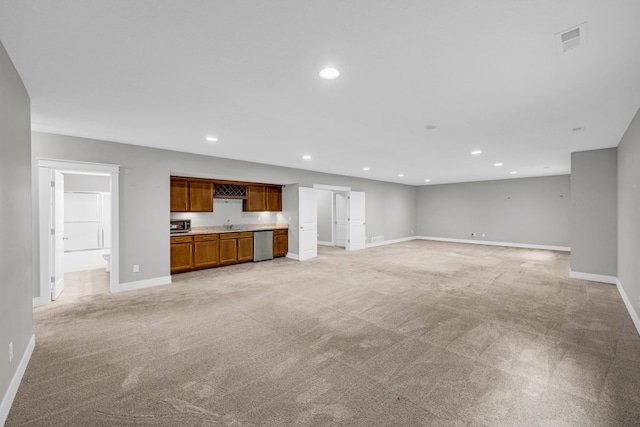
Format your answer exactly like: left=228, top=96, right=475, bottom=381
left=33, top=159, right=119, bottom=306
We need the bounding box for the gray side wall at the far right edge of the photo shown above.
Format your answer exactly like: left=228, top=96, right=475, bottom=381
left=618, top=110, right=640, bottom=324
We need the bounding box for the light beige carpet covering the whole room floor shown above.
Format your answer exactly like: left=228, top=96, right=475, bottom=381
left=7, top=241, right=640, bottom=426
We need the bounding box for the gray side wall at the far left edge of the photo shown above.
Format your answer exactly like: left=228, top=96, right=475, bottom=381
left=0, top=43, right=33, bottom=424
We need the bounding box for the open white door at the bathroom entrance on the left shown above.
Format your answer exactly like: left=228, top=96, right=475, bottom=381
left=51, top=171, right=64, bottom=301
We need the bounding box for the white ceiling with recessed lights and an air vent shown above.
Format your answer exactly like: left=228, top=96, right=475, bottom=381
left=0, top=0, right=640, bottom=185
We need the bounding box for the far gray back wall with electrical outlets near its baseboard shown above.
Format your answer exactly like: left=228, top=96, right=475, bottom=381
left=417, top=175, right=570, bottom=247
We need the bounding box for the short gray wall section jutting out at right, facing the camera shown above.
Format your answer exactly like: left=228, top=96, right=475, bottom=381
left=571, top=148, right=618, bottom=276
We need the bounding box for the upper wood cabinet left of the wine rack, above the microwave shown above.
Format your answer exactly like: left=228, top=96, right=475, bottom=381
left=171, top=176, right=214, bottom=212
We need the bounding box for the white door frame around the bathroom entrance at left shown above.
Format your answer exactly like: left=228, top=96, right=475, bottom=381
left=33, top=158, right=120, bottom=307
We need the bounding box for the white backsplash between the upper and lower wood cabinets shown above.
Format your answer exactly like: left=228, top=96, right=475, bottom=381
left=171, top=199, right=289, bottom=227
